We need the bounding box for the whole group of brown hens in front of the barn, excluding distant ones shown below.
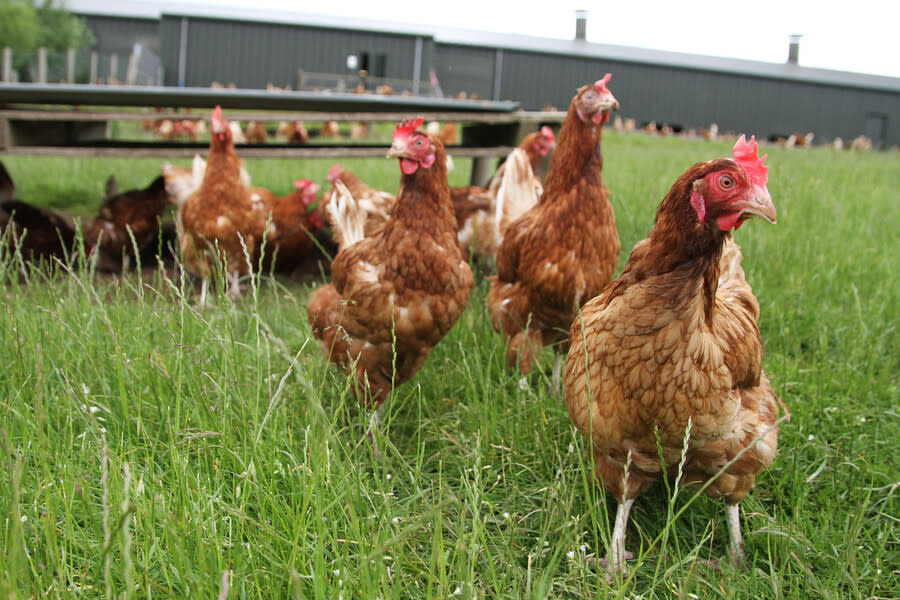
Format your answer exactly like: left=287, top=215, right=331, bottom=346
left=3, top=74, right=779, bottom=572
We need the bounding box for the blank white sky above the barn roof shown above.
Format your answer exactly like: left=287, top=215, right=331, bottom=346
left=183, top=0, right=900, bottom=77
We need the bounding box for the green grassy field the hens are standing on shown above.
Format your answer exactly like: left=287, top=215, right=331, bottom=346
left=0, top=133, right=900, bottom=600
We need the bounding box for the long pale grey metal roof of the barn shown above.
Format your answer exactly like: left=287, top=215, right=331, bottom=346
left=69, top=0, right=900, bottom=92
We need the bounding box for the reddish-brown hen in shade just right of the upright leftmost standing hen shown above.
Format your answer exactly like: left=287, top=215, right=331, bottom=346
left=262, top=179, right=334, bottom=275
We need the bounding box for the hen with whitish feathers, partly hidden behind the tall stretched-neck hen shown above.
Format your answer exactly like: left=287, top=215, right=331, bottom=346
left=458, top=125, right=556, bottom=258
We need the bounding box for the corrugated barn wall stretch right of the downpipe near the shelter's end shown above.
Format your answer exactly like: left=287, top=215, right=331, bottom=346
left=500, top=46, right=900, bottom=146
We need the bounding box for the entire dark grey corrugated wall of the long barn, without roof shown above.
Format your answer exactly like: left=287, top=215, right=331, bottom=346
left=79, top=15, right=900, bottom=147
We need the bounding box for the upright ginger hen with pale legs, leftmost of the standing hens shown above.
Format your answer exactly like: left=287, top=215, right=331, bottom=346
left=175, top=106, right=274, bottom=306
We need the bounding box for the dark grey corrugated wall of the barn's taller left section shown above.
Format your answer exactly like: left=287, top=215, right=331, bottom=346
left=160, top=15, right=431, bottom=89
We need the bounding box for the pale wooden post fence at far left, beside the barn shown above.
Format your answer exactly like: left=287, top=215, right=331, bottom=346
left=2, top=44, right=163, bottom=85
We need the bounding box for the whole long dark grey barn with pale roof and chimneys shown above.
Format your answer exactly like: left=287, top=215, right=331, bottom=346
left=70, top=0, right=900, bottom=148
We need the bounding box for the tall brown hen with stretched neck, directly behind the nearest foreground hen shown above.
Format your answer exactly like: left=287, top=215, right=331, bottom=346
left=488, top=73, right=619, bottom=390
